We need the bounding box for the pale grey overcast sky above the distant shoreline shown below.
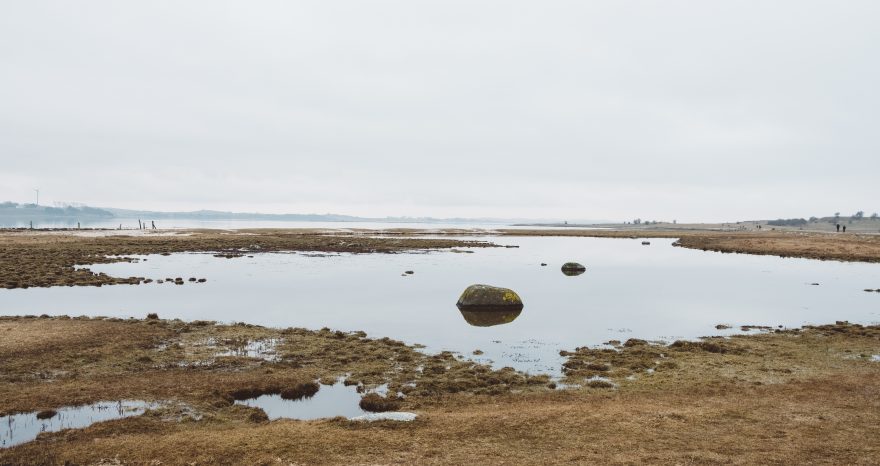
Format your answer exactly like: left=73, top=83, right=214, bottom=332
left=0, top=0, right=880, bottom=221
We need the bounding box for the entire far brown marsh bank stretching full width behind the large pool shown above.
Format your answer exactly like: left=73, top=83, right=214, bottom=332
left=6, top=229, right=880, bottom=288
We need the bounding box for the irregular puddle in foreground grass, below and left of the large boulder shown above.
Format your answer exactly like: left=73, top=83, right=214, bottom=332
left=235, top=380, right=415, bottom=421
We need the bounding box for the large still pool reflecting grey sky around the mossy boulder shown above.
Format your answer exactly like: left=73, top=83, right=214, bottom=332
left=0, top=237, right=880, bottom=374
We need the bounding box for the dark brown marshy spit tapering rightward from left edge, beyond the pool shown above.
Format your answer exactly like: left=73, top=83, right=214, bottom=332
left=0, top=229, right=493, bottom=288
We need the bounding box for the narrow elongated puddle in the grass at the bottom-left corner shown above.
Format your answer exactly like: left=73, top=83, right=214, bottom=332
left=0, top=400, right=158, bottom=448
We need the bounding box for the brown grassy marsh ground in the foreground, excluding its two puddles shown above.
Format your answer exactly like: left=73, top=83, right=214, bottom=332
left=0, top=317, right=880, bottom=464
